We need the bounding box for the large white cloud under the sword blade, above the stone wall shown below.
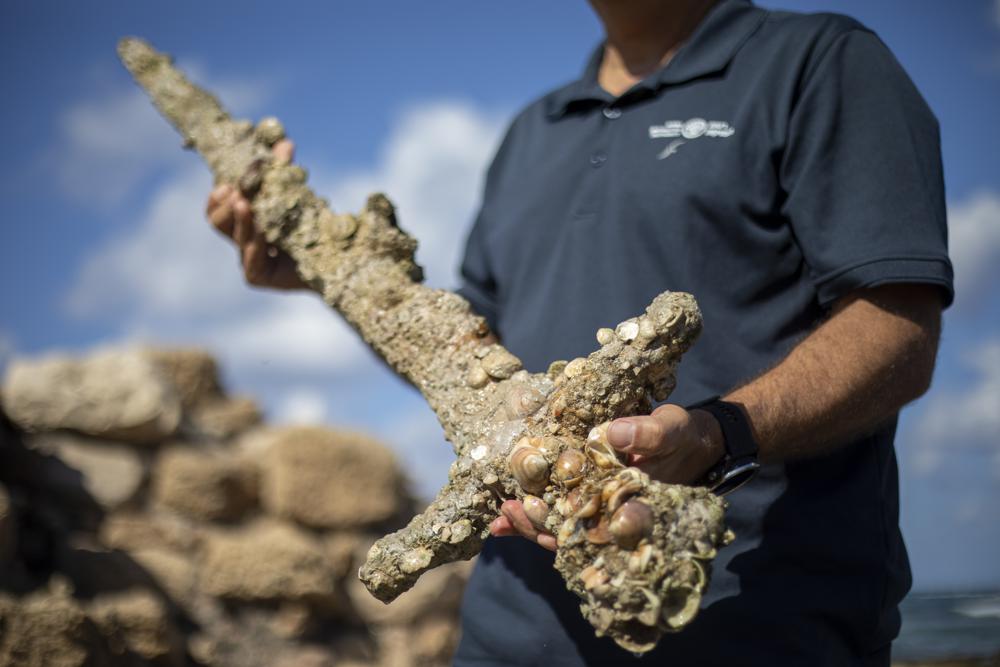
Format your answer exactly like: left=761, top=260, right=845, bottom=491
left=67, top=167, right=368, bottom=373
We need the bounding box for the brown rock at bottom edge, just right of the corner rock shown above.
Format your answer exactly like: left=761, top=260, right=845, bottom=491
left=89, top=590, right=184, bottom=666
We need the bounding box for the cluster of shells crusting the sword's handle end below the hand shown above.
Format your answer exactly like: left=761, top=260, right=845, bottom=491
left=500, top=420, right=730, bottom=652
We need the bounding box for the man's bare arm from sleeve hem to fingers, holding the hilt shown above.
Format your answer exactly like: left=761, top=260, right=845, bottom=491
left=493, top=284, right=941, bottom=548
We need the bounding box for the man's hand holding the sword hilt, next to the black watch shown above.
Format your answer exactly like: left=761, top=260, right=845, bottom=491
left=490, top=405, right=724, bottom=551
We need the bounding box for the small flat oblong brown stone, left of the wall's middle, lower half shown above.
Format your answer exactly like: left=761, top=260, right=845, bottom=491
left=98, top=512, right=199, bottom=552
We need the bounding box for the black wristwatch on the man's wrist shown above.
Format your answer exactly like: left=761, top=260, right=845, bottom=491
left=685, top=396, right=760, bottom=496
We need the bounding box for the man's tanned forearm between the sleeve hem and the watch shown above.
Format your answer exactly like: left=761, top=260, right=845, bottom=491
left=725, top=285, right=941, bottom=461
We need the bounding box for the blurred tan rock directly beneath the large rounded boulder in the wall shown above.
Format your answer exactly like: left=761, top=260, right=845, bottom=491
left=200, top=521, right=336, bottom=602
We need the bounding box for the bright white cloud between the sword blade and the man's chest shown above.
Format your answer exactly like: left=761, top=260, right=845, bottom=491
left=317, top=101, right=502, bottom=287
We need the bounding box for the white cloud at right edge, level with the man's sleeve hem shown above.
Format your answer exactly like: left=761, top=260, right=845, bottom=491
left=948, top=191, right=1000, bottom=305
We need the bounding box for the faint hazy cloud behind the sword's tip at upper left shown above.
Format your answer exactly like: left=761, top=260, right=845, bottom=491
left=47, top=63, right=271, bottom=206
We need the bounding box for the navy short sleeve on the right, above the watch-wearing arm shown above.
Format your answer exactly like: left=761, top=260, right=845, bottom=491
left=780, top=29, right=954, bottom=305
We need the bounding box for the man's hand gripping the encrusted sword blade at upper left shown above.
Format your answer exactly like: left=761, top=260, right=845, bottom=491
left=205, top=139, right=308, bottom=290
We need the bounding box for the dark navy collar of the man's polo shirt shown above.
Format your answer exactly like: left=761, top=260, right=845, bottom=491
left=547, top=0, right=767, bottom=117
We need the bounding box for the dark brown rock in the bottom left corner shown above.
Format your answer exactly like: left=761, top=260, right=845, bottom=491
left=0, top=590, right=115, bottom=667
